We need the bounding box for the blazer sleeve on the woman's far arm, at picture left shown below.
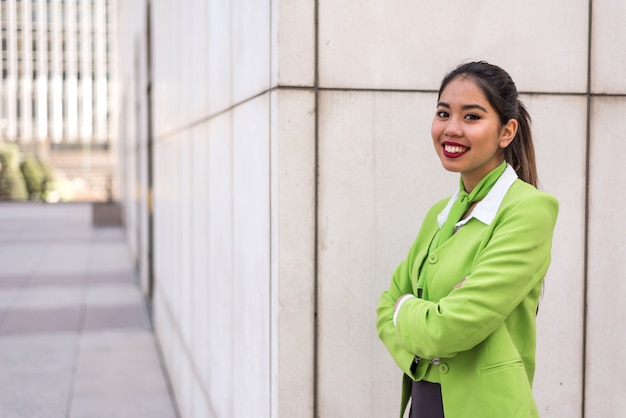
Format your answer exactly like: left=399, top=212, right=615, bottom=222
left=376, top=199, right=447, bottom=376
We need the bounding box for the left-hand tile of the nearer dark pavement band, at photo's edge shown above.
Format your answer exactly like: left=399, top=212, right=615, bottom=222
left=0, top=306, right=81, bottom=335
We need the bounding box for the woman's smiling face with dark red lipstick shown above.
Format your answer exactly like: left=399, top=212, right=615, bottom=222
left=431, top=76, right=517, bottom=192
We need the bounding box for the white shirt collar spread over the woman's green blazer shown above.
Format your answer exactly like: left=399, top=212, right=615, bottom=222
left=437, top=164, right=517, bottom=228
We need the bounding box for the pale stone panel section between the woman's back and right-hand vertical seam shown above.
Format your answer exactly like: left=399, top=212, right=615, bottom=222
left=522, top=95, right=587, bottom=418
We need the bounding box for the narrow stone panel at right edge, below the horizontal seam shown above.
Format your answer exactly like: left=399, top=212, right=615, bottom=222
left=585, top=97, right=626, bottom=417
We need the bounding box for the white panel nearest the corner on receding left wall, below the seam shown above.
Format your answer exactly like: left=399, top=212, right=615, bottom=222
left=231, top=94, right=270, bottom=417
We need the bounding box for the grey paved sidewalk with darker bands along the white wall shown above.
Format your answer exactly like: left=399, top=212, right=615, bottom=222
left=0, top=203, right=177, bottom=418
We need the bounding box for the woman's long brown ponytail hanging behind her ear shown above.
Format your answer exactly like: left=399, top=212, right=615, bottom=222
left=504, top=100, right=538, bottom=187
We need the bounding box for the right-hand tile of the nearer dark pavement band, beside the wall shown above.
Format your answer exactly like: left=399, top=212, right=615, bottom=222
left=83, top=304, right=150, bottom=331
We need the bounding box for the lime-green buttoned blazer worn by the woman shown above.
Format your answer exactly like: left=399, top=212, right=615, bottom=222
left=377, top=179, right=558, bottom=418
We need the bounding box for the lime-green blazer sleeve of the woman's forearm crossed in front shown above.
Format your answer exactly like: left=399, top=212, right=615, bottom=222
left=395, top=192, right=558, bottom=358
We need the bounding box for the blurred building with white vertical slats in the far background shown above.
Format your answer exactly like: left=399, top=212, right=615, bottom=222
left=0, top=0, right=117, bottom=200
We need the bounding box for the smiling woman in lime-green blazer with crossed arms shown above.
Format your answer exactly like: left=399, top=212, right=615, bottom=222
left=377, top=62, right=558, bottom=418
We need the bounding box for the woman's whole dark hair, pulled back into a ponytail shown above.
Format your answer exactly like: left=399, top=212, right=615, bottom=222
left=439, top=61, right=538, bottom=187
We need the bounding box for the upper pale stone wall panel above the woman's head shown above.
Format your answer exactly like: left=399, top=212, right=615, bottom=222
left=319, top=0, right=588, bottom=92
